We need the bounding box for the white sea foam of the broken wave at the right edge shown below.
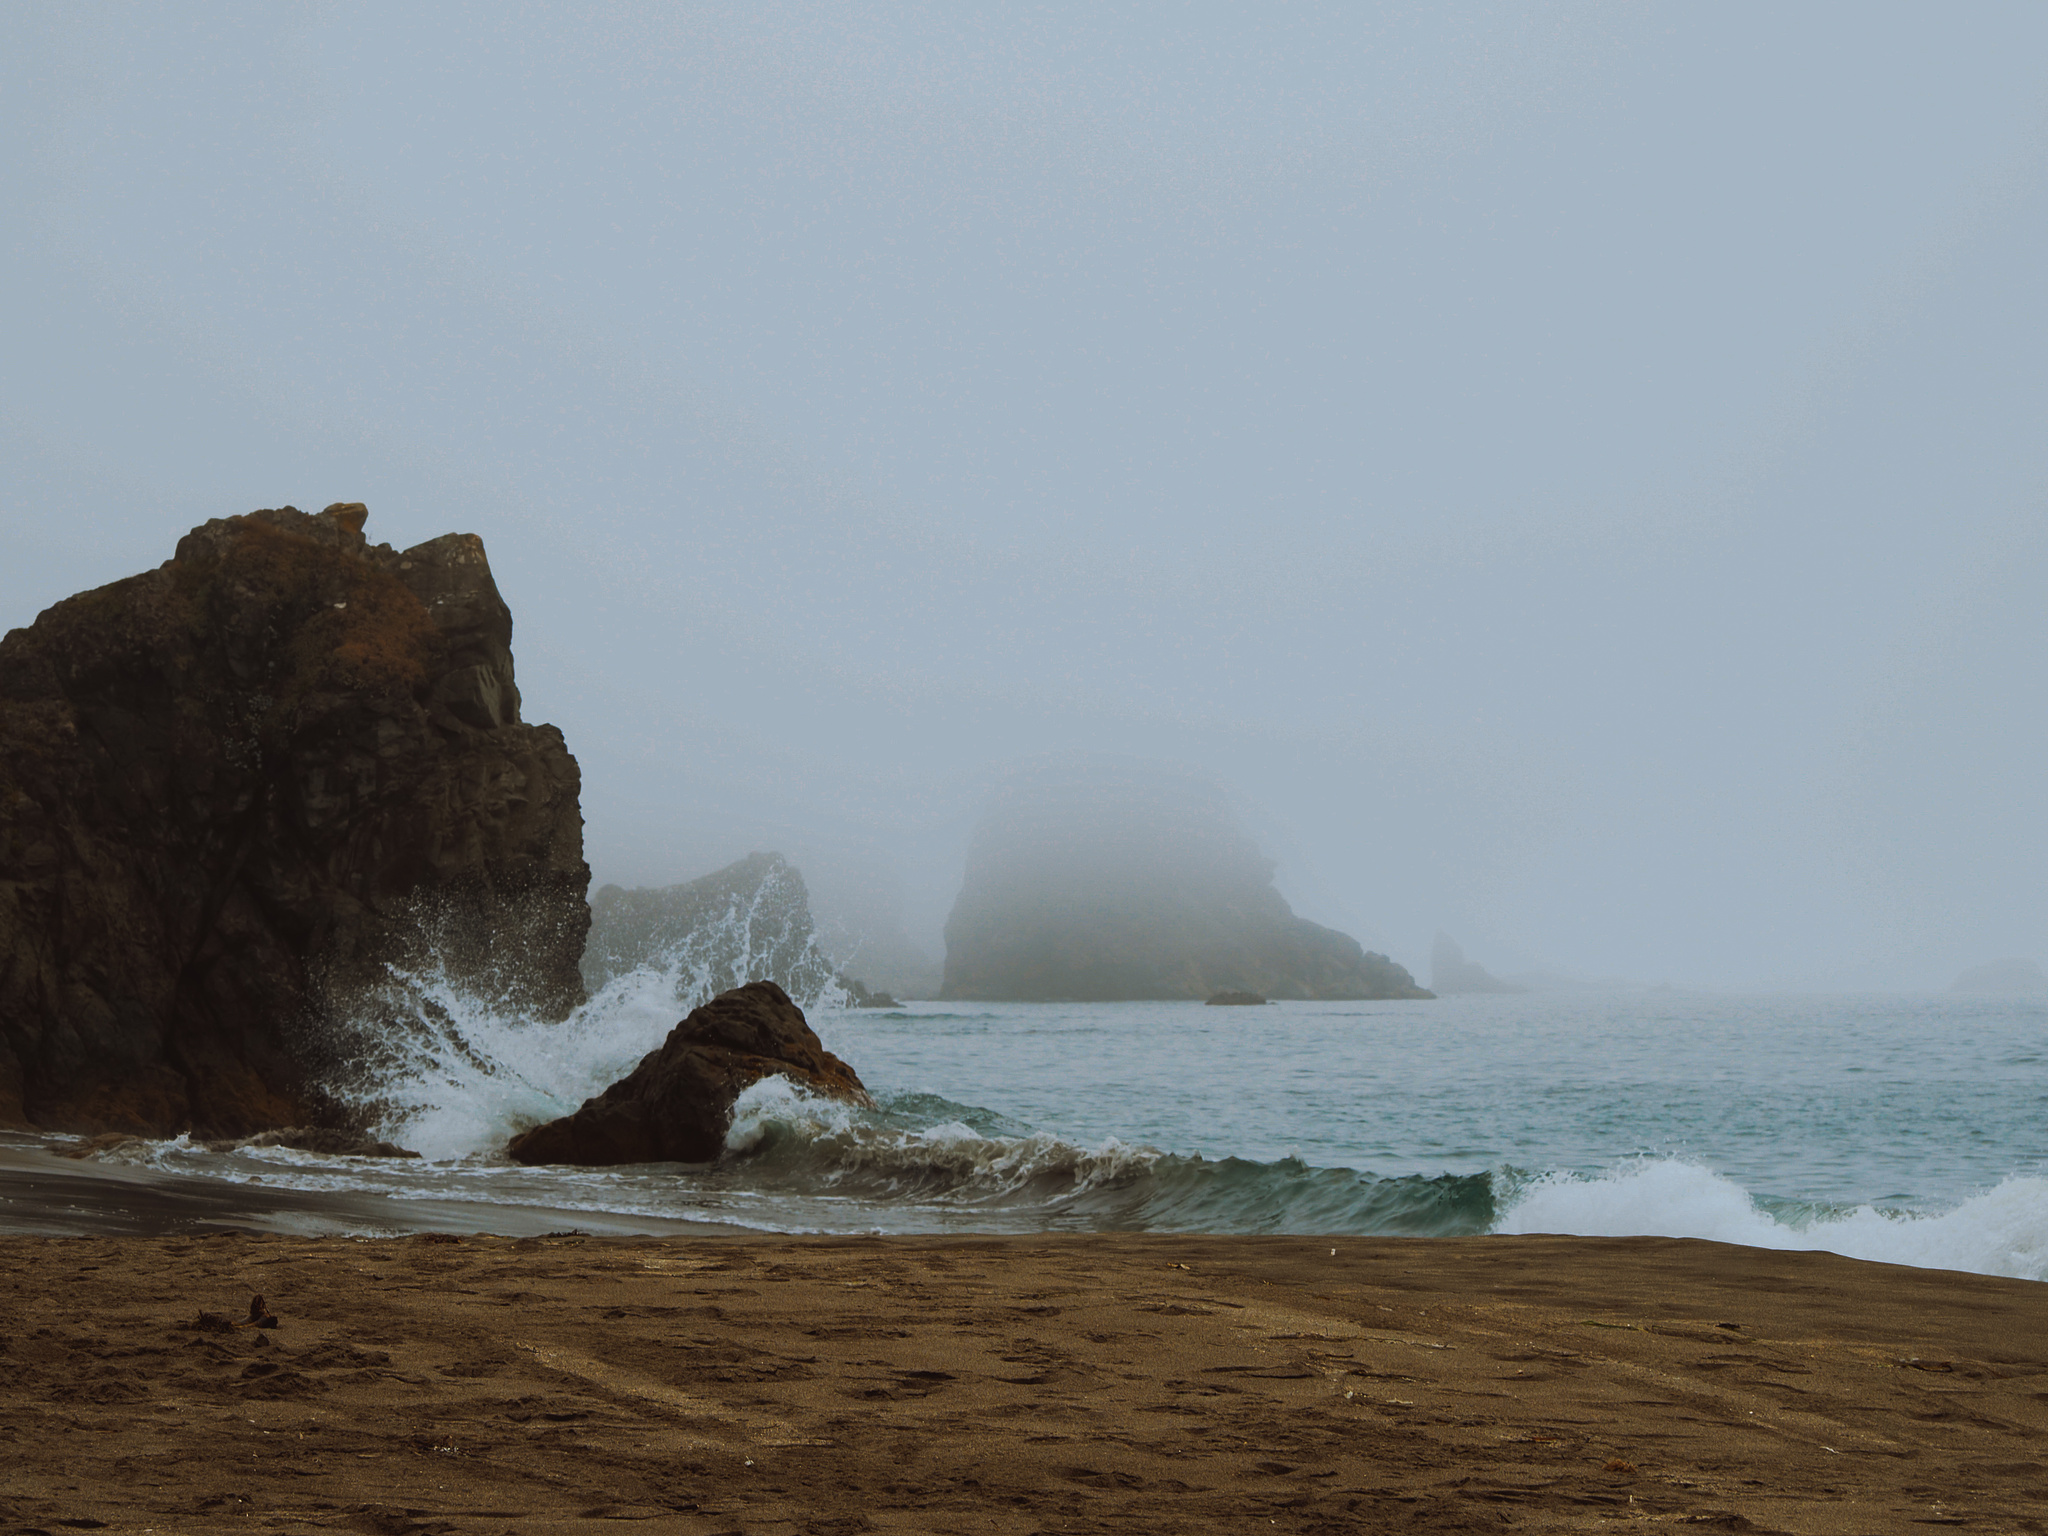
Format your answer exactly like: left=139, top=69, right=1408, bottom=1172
left=1493, top=1159, right=2048, bottom=1280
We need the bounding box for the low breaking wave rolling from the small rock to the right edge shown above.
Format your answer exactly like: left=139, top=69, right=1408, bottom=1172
left=692, top=1079, right=2048, bottom=1280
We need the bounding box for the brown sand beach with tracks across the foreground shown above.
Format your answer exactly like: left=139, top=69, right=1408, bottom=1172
left=0, top=1235, right=2048, bottom=1534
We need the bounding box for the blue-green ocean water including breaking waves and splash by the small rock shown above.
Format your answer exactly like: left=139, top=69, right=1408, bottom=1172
left=16, top=969, right=2048, bottom=1280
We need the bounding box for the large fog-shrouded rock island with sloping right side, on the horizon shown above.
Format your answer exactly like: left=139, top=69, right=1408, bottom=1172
left=940, top=770, right=1432, bottom=1001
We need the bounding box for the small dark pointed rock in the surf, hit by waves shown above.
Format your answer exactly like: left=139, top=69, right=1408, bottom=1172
left=506, top=981, right=868, bottom=1167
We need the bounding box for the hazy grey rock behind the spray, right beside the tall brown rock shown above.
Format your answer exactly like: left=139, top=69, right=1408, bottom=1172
left=584, top=854, right=836, bottom=1008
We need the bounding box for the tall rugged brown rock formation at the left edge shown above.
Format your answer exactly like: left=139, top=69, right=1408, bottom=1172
left=0, top=504, right=590, bottom=1137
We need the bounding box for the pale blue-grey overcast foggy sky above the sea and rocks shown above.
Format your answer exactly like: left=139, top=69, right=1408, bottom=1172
left=0, top=0, right=2048, bottom=987
